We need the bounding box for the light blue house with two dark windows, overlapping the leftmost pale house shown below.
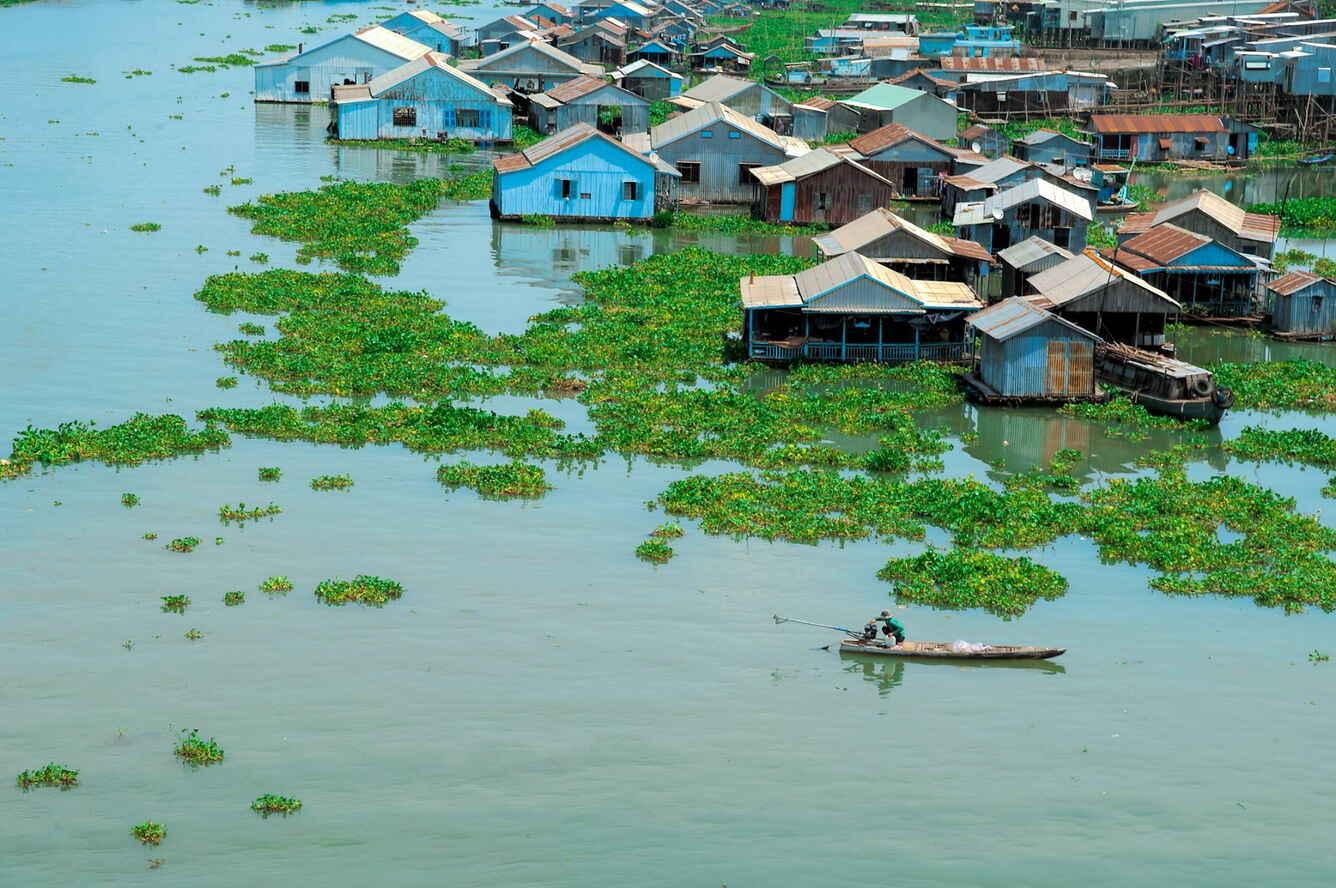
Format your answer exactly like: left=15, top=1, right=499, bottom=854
left=330, top=52, right=512, bottom=143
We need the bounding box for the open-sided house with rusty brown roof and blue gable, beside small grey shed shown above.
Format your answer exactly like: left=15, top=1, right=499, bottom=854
left=1104, top=222, right=1261, bottom=318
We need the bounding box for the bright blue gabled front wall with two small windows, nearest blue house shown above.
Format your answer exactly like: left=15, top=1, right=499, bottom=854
left=492, top=139, right=655, bottom=219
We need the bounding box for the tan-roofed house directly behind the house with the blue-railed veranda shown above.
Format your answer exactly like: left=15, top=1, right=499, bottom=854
left=812, top=207, right=993, bottom=287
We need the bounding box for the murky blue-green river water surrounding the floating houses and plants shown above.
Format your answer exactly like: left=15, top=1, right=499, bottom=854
left=0, top=0, right=1336, bottom=887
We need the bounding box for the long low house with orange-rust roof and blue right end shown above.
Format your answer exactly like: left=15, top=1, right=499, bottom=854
left=1090, top=114, right=1257, bottom=163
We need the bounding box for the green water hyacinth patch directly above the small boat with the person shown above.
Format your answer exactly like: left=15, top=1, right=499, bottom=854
left=876, top=549, right=1067, bottom=620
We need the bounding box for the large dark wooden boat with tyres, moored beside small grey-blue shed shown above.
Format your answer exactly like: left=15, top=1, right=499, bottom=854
left=1094, top=343, right=1234, bottom=425
